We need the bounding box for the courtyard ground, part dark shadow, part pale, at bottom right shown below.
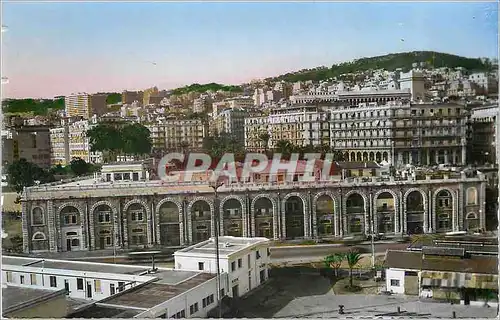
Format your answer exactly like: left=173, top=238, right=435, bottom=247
left=238, top=268, right=497, bottom=318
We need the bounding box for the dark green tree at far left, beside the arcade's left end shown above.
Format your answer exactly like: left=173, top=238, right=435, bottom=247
left=7, top=158, right=55, bottom=193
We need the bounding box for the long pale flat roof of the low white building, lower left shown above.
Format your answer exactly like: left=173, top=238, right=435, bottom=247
left=2, top=256, right=149, bottom=275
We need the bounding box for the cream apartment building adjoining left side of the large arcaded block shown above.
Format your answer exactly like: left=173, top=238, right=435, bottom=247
left=245, top=105, right=330, bottom=150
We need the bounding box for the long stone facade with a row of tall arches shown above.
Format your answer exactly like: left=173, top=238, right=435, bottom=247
left=22, top=174, right=486, bottom=252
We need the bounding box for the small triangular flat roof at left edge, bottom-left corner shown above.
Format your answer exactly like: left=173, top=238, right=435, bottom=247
left=2, top=285, right=65, bottom=315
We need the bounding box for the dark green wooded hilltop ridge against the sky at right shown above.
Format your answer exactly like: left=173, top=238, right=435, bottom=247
left=266, top=51, right=491, bottom=82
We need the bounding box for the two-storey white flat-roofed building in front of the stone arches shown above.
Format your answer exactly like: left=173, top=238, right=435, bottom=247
left=174, top=236, right=270, bottom=297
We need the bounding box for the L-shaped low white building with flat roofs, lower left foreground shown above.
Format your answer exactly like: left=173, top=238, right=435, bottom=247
left=2, top=256, right=228, bottom=319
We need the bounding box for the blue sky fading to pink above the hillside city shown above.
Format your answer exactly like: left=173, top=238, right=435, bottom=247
left=1, top=1, right=498, bottom=98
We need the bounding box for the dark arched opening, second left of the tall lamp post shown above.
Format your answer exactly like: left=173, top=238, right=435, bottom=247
left=159, top=201, right=181, bottom=246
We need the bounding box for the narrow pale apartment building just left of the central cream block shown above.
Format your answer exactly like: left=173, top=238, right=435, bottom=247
left=214, top=108, right=248, bottom=145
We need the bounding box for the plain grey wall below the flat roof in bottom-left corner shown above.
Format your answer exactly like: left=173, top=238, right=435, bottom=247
left=2, top=295, right=68, bottom=319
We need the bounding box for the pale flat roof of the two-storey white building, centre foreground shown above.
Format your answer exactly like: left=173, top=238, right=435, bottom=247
left=174, top=236, right=270, bottom=257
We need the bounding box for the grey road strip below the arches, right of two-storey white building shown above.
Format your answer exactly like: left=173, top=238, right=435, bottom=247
left=271, top=243, right=408, bottom=261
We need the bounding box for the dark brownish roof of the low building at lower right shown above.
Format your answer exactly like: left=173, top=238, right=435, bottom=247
left=385, top=250, right=498, bottom=274
